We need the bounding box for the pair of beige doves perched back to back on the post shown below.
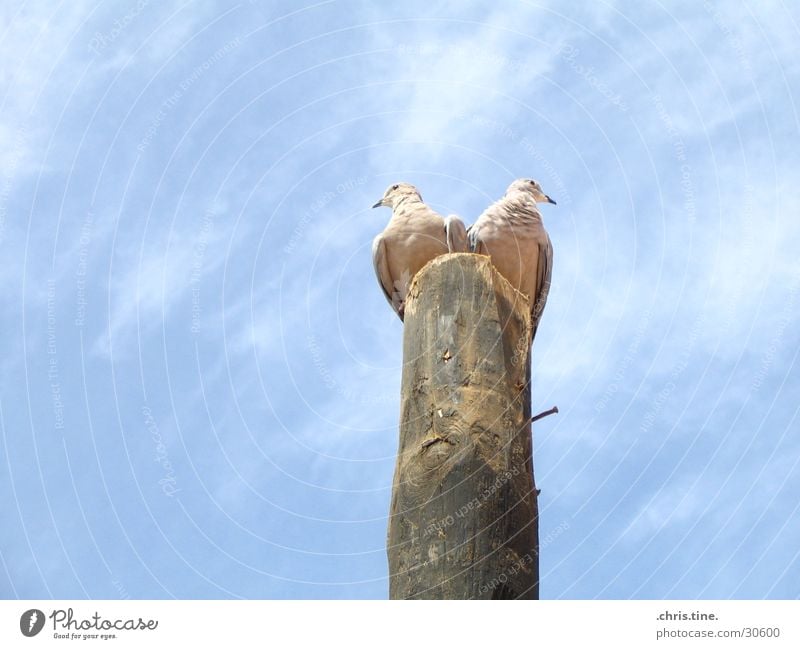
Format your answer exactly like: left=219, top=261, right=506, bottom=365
left=372, top=178, right=556, bottom=334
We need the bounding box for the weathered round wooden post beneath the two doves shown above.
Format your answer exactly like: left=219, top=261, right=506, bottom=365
left=388, top=254, right=539, bottom=599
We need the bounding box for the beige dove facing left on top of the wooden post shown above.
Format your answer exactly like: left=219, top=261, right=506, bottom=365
left=372, top=183, right=469, bottom=320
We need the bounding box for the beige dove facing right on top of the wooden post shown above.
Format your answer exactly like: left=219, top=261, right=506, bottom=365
left=468, top=178, right=556, bottom=340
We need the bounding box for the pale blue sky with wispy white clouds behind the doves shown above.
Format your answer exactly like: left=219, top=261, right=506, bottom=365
left=0, top=0, right=800, bottom=599
